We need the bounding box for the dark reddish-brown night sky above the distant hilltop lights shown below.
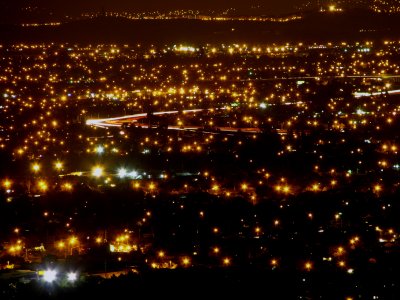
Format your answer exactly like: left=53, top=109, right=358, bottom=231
left=0, top=0, right=308, bottom=14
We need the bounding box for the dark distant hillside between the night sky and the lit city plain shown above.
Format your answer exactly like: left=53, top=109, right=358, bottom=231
left=0, top=10, right=400, bottom=44
